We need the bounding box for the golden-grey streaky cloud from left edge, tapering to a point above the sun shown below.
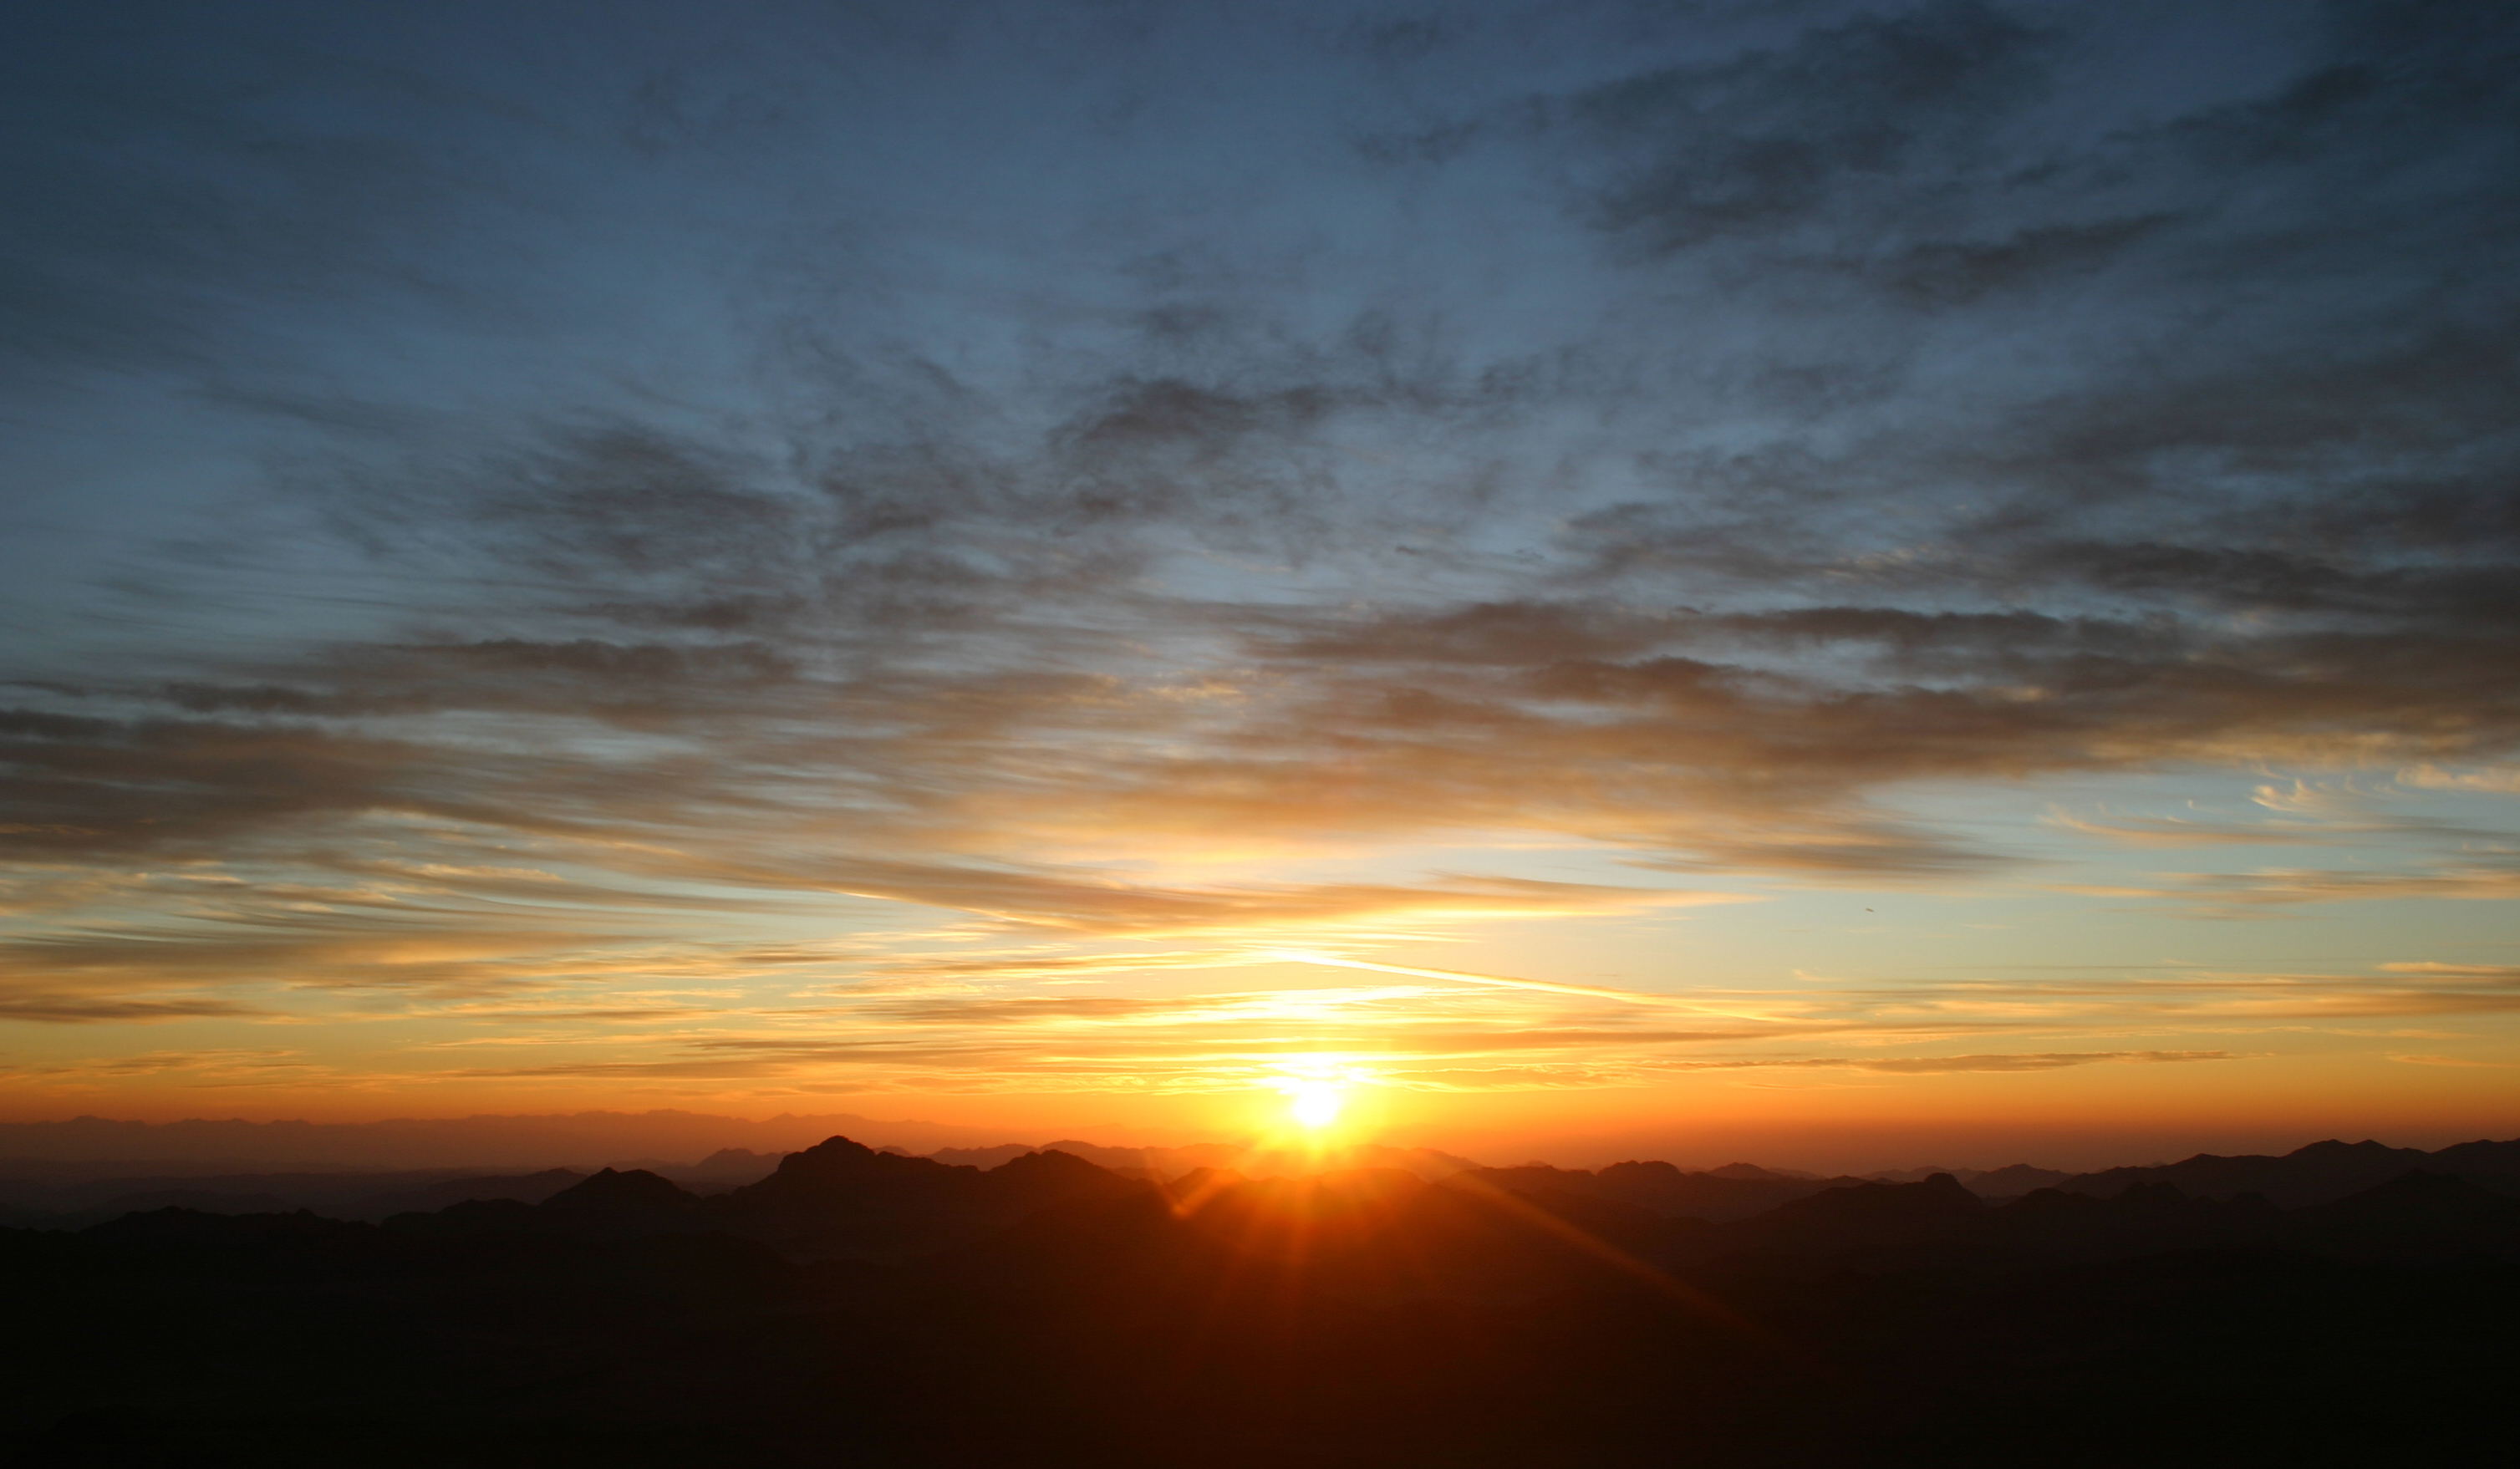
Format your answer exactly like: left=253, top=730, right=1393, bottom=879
left=0, top=854, right=1731, bottom=1023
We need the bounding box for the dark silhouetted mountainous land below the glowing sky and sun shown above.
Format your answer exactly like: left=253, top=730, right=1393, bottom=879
left=0, top=1139, right=2520, bottom=1466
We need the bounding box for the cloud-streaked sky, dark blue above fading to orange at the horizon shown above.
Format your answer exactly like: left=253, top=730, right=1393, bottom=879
left=0, top=0, right=2520, bottom=1167
